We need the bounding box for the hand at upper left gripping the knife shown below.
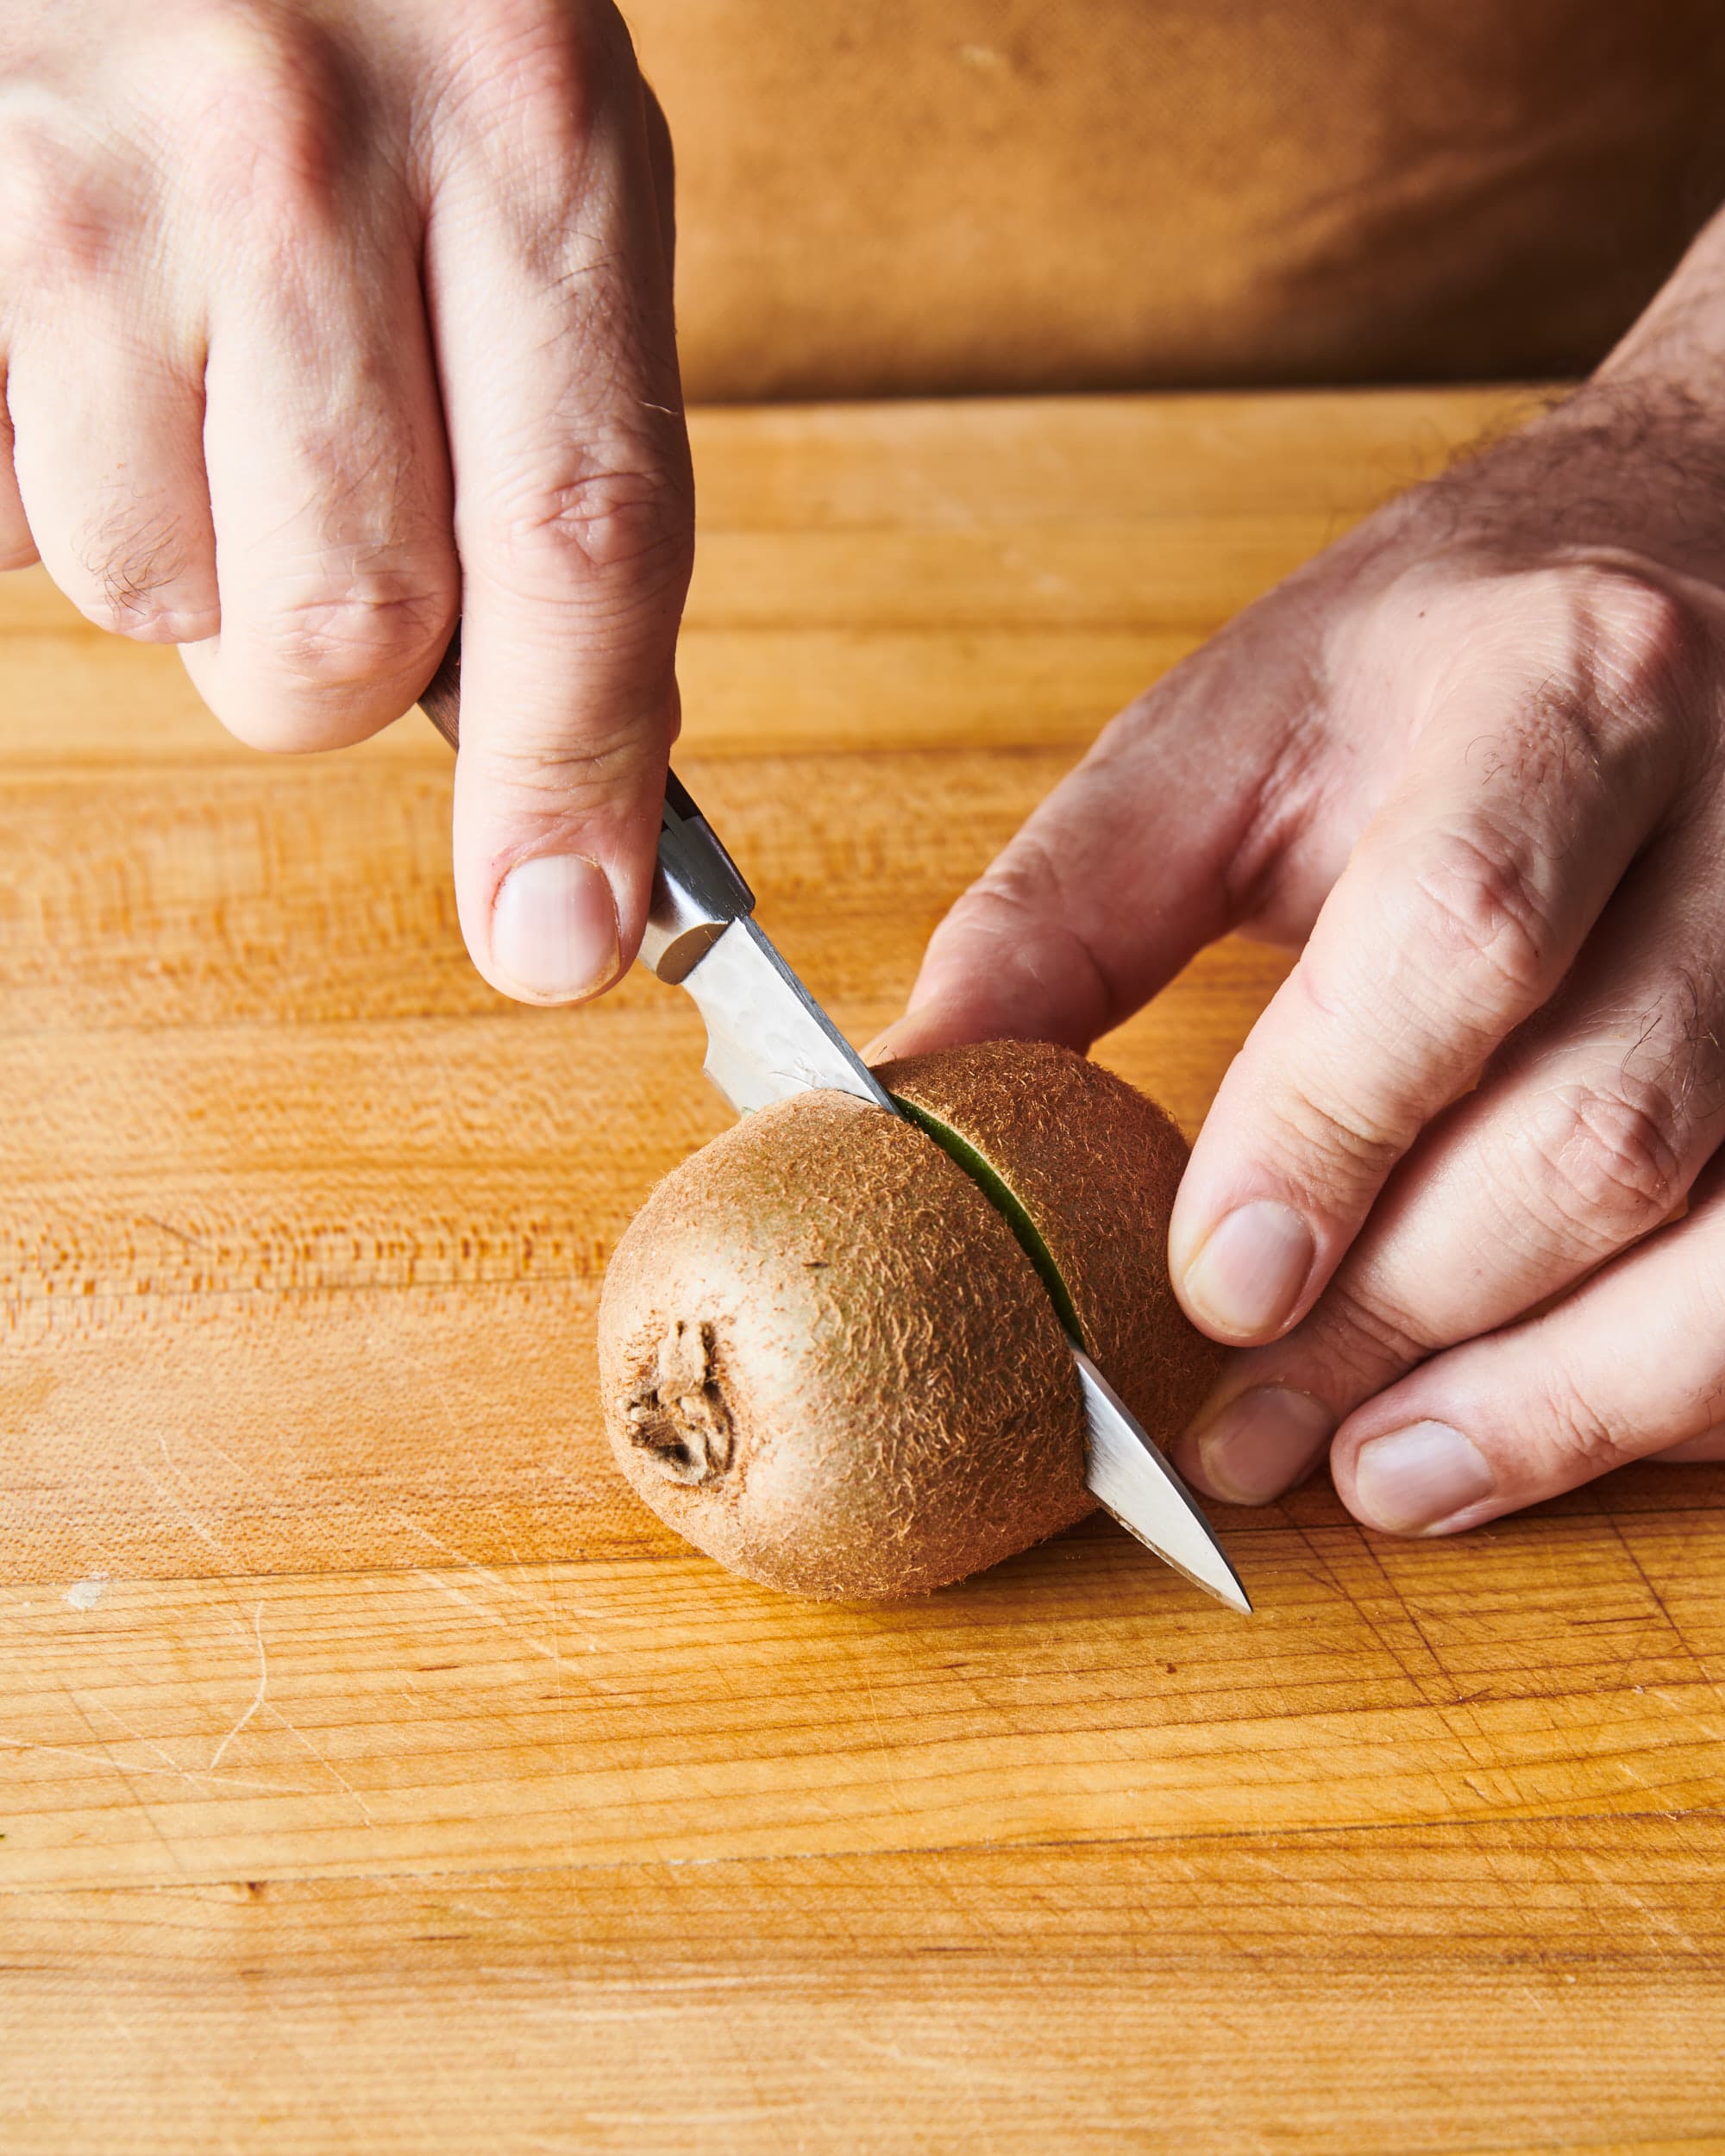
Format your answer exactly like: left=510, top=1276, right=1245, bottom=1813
left=0, top=0, right=693, bottom=1003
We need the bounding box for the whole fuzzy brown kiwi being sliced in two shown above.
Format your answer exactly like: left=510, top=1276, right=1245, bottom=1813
left=599, top=1042, right=1219, bottom=1600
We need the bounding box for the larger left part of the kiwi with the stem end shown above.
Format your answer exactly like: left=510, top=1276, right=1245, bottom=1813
left=599, top=1094, right=1095, bottom=1600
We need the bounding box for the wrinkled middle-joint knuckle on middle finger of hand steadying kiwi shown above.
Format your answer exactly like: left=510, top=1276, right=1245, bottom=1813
left=1531, top=1072, right=1682, bottom=1250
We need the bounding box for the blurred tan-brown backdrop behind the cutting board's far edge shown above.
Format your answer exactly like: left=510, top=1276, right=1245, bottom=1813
left=624, top=0, right=1725, bottom=399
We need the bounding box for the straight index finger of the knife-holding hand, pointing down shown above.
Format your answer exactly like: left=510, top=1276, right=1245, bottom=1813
left=425, top=9, right=694, bottom=1003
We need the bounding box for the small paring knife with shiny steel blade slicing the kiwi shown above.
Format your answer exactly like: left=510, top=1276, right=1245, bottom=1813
left=421, top=641, right=1251, bottom=1615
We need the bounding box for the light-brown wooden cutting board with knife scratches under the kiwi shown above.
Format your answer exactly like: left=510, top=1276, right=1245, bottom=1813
left=0, top=392, right=1725, bottom=2156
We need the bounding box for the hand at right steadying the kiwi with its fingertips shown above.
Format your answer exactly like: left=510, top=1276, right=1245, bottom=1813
left=882, top=244, right=1725, bottom=1533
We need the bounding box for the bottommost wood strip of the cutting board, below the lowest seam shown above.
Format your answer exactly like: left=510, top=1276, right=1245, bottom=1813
left=0, top=1815, right=1725, bottom=2156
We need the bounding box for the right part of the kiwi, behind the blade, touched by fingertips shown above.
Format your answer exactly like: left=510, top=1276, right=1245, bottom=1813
left=875, top=1042, right=1223, bottom=1447
